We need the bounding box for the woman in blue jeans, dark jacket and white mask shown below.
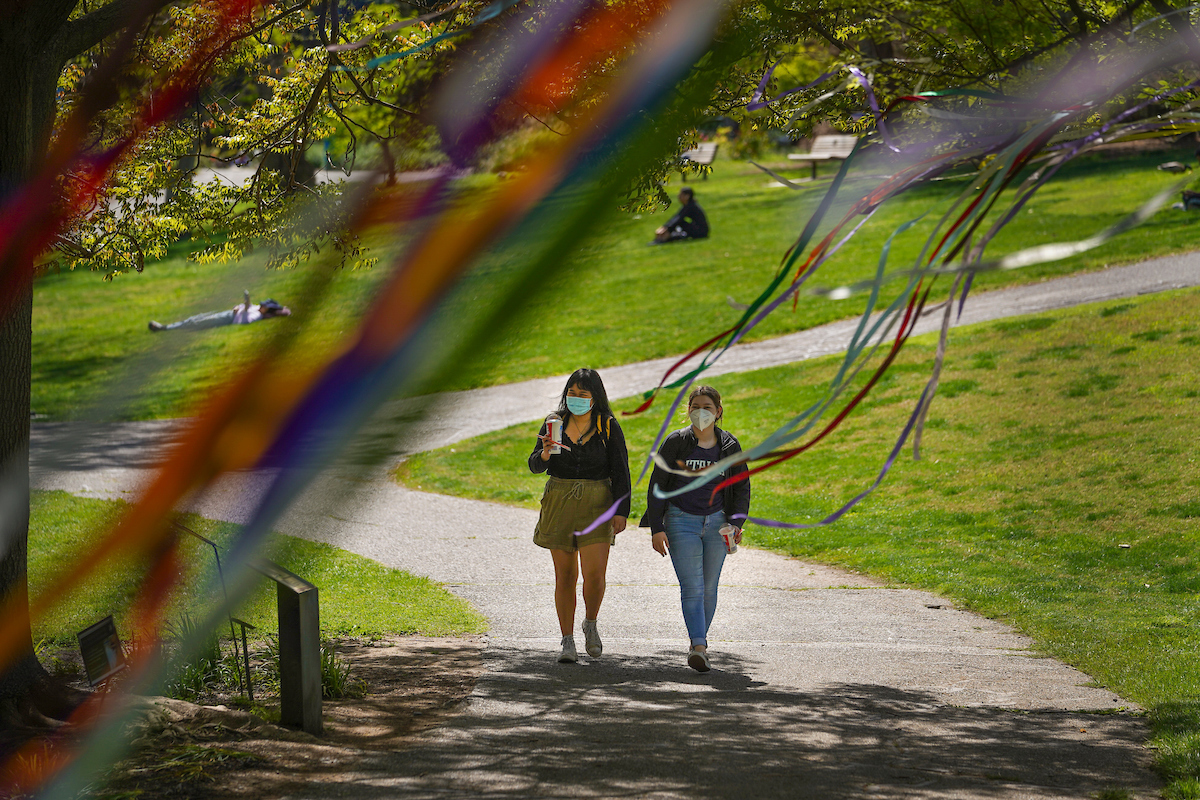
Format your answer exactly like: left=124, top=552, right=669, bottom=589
left=641, top=386, right=750, bottom=672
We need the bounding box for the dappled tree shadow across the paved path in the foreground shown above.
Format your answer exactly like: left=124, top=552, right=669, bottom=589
left=278, top=645, right=1158, bottom=800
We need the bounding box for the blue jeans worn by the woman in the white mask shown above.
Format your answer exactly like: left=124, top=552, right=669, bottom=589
left=666, top=505, right=725, bottom=648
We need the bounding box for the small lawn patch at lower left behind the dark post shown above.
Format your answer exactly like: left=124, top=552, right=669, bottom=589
left=29, top=492, right=486, bottom=645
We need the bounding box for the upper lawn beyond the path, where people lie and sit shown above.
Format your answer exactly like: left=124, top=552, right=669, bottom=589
left=32, top=152, right=1200, bottom=419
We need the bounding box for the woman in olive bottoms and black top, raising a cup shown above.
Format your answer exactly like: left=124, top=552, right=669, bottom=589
left=529, top=369, right=630, bottom=662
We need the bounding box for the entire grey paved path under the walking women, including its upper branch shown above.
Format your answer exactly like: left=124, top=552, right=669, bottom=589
left=31, top=255, right=1200, bottom=799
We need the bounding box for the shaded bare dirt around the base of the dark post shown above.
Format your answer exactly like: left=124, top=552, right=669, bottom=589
left=95, top=637, right=484, bottom=799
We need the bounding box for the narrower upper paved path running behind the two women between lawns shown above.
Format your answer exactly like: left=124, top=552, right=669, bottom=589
left=31, top=252, right=1200, bottom=484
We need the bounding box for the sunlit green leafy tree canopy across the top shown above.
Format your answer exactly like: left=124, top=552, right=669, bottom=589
left=48, top=0, right=1200, bottom=276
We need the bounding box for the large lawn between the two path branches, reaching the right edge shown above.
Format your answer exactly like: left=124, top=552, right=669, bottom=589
left=397, top=290, right=1200, bottom=798
